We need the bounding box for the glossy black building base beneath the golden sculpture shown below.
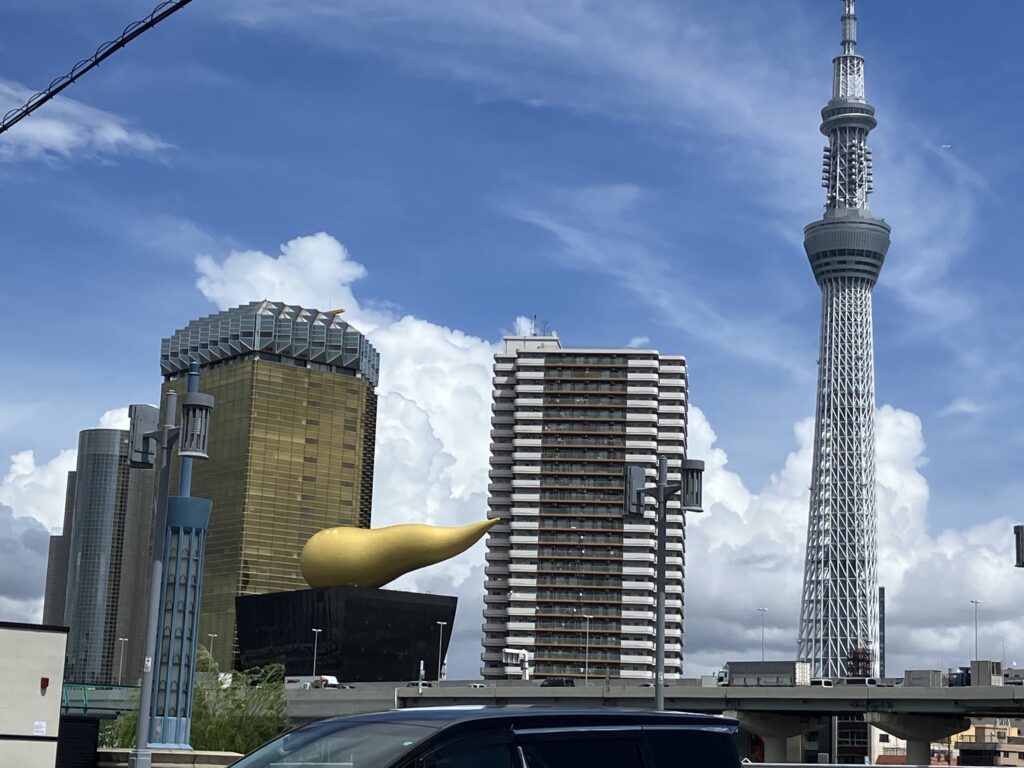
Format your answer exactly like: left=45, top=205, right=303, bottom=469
left=234, top=587, right=458, bottom=683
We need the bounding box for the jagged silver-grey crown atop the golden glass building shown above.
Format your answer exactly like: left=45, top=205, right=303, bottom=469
left=160, top=301, right=380, bottom=387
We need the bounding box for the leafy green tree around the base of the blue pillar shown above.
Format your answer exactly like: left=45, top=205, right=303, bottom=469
left=101, top=647, right=289, bottom=754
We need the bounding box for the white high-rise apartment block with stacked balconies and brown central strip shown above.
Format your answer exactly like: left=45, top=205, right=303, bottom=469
left=481, top=334, right=687, bottom=679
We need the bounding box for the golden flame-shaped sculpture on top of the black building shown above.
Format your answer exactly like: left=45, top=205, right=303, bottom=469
left=301, top=518, right=498, bottom=588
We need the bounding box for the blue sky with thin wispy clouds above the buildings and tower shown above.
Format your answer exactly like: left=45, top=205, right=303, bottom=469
left=0, top=0, right=1024, bottom=664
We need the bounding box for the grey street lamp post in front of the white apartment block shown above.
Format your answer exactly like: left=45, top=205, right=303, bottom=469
left=625, top=456, right=703, bottom=711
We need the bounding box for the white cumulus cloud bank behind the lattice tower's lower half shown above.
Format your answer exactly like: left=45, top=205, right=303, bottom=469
left=686, top=406, right=1024, bottom=674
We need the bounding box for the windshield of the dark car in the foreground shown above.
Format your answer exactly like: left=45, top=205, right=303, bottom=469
left=233, top=721, right=436, bottom=768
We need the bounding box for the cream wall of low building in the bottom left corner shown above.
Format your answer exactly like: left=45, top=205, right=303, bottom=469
left=0, top=622, right=68, bottom=768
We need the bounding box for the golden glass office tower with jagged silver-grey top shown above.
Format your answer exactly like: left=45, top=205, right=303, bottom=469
left=160, top=301, right=380, bottom=670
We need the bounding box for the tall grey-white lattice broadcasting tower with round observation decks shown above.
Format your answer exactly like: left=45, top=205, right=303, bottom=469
left=798, top=0, right=889, bottom=677
